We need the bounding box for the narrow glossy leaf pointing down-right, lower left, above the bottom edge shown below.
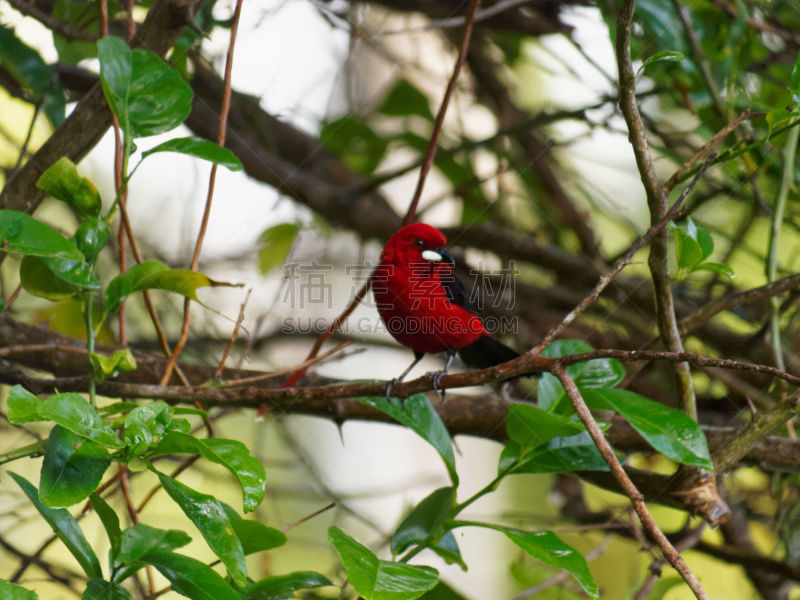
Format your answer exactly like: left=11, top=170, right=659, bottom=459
left=153, top=469, right=247, bottom=586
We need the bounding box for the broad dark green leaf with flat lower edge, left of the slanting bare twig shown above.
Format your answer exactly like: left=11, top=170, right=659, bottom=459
left=504, top=431, right=609, bottom=473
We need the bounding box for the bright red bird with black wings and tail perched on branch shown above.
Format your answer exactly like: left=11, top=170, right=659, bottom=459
left=372, top=223, right=519, bottom=394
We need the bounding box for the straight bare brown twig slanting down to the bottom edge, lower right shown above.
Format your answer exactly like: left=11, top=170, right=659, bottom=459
left=553, top=365, right=708, bottom=600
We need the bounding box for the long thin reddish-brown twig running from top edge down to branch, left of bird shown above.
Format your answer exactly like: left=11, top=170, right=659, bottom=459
left=161, top=0, right=242, bottom=385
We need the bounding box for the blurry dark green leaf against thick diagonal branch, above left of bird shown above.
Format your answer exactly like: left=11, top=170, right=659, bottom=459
left=319, top=115, right=389, bottom=176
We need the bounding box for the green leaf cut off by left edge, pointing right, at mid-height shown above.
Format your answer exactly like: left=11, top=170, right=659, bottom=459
left=0, top=209, right=83, bottom=262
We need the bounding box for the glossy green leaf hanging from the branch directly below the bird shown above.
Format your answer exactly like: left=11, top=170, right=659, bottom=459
left=356, top=394, right=458, bottom=485
